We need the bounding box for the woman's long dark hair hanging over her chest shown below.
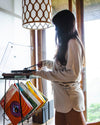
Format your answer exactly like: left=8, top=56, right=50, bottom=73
left=52, top=10, right=78, bottom=65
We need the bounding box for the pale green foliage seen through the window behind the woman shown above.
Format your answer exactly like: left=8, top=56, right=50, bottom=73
left=87, top=104, right=100, bottom=122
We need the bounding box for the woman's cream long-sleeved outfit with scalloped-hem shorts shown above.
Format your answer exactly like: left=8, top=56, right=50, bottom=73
left=36, top=39, right=85, bottom=113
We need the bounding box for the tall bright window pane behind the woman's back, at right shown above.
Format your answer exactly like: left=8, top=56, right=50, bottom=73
left=84, top=1, right=100, bottom=122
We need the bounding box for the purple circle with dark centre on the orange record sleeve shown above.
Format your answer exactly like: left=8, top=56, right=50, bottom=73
left=10, top=101, right=21, bottom=117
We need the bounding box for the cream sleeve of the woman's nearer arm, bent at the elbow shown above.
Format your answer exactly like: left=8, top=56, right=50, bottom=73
left=36, top=39, right=82, bottom=82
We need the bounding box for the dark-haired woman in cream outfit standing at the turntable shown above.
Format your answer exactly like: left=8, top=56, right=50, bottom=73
left=33, top=10, right=85, bottom=125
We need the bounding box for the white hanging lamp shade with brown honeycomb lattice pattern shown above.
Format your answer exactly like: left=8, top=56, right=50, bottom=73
left=22, top=0, right=51, bottom=30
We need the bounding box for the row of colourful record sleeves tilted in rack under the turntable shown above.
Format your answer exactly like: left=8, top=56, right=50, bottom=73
left=0, top=81, right=47, bottom=125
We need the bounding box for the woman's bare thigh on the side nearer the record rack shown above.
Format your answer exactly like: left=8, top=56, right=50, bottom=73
left=55, top=112, right=68, bottom=125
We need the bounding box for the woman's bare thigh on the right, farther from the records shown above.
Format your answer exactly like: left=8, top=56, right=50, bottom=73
left=66, top=109, right=86, bottom=125
